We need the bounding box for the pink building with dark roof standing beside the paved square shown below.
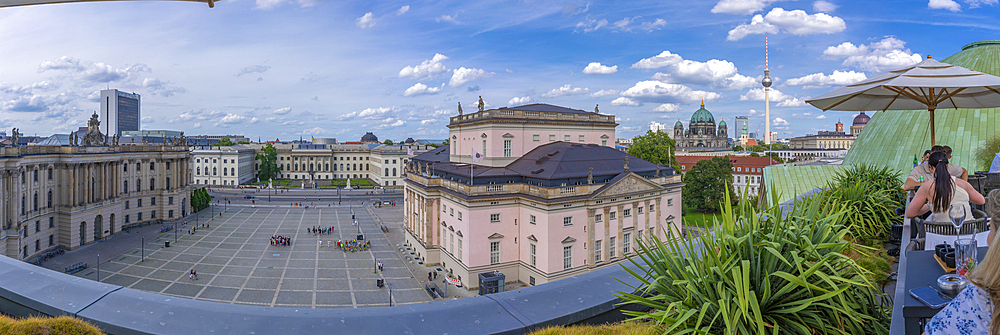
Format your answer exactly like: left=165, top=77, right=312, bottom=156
left=404, top=104, right=682, bottom=289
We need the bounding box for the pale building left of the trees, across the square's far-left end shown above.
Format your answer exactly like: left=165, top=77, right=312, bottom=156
left=190, top=145, right=257, bottom=186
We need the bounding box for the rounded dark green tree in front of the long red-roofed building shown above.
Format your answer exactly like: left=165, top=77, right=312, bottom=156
left=683, top=156, right=736, bottom=213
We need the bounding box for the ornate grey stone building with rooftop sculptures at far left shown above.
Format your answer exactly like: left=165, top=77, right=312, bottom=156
left=0, top=115, right=190, bottom=260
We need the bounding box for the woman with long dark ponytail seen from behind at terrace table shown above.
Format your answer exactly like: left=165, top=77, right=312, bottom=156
left=906, top=152, right=986, bottom=222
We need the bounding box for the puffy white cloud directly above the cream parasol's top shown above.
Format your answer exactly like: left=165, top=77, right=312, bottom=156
left=823, top=36, right=922, bottom=72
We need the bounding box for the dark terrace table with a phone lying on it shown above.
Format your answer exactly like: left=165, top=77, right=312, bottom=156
left=903, top=247, right=988, bottom=335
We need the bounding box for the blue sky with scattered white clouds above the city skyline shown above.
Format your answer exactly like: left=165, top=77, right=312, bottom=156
left=0, top=0, right=1000, bottom=141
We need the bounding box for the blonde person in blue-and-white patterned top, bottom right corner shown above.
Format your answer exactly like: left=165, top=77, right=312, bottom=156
left=924, top=214, right=1000, bottom=335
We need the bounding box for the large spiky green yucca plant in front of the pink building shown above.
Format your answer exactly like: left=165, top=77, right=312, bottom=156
left=617, top=190, right=889, bottom=335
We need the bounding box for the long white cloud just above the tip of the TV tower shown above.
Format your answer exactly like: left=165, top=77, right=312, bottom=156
left=726, top=8, right=847, bottom=41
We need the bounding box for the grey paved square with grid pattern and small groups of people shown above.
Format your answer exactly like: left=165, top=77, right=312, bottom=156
left=77, top=206, right=431, bottom=308
